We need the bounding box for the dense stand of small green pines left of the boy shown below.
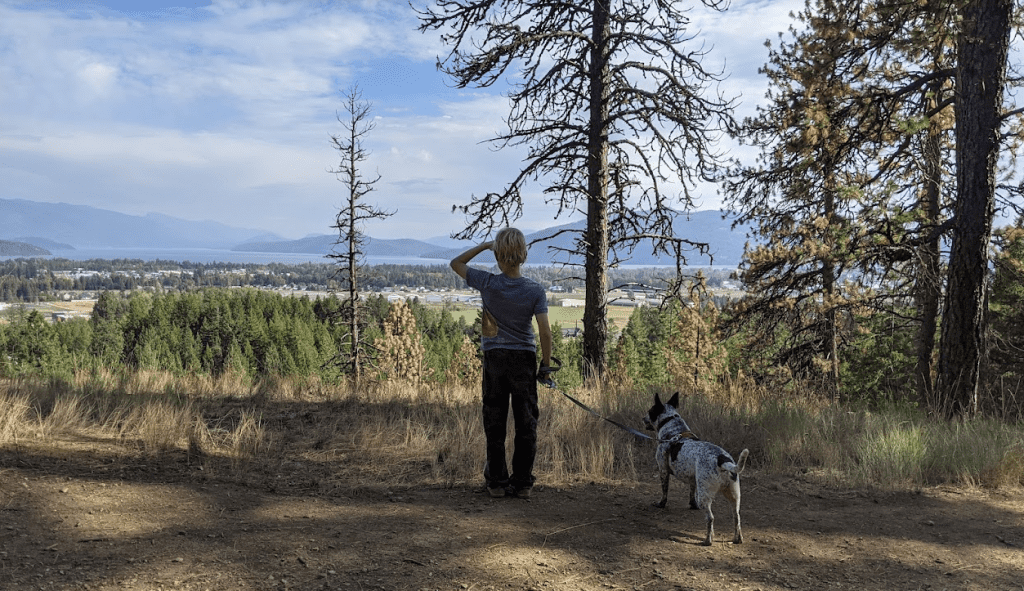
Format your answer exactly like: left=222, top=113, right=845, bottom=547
left=0, top=289, right=479, bottom=383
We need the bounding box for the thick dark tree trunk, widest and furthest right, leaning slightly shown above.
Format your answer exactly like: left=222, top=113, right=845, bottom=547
left=939, top=0, right=1014, bottom=417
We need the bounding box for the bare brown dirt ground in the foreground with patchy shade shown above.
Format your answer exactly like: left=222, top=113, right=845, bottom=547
left=0, top=439, right=1024, bottom=591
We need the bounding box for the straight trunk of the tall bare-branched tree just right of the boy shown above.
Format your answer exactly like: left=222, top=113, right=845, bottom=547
left=583, top=0, right=609, bottom=379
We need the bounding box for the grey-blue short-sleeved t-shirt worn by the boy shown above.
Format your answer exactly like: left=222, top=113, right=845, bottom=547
left=466, top=267, right=548, bottom=351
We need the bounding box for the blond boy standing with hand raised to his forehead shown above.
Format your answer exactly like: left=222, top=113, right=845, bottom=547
left=452, top=227, right=551, bottom=499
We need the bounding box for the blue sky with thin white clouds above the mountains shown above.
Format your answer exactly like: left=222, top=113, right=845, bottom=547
left=0, top=0, right=803, bottom=239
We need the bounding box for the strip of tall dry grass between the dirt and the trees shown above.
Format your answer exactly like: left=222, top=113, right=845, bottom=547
left=0, top=371, right=1024, bottom=492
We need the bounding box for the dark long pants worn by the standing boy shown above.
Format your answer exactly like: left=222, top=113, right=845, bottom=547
left=483, top=349, right=541, bottom=489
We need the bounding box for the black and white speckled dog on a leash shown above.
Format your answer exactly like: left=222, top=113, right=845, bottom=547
left=644, top=392, right=750, bottom=546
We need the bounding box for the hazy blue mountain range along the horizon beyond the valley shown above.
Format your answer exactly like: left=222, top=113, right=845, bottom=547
left=0, top=199, right=748, bottom=265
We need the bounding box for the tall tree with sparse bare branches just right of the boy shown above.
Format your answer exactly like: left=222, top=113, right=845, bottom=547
left=421, top=0, right=732, bottom=377
